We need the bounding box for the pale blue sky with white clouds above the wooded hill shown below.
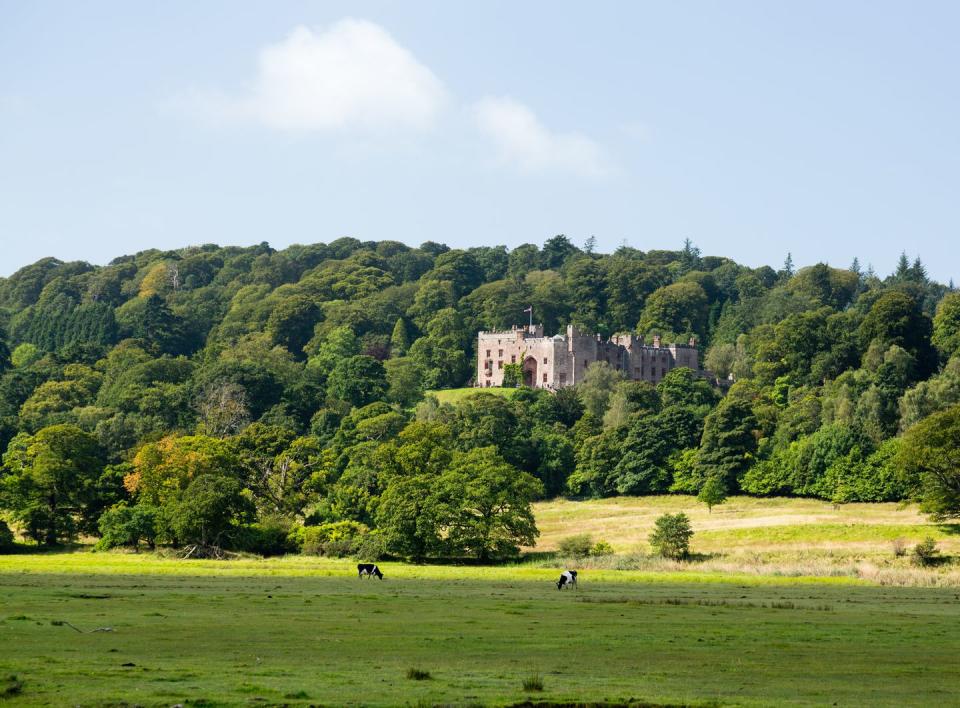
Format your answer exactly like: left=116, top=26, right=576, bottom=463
left=0, top=0, right=960, bottom=281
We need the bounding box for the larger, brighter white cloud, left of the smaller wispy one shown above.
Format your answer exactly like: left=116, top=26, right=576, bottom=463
left=187, top=19, right=445, bottom=132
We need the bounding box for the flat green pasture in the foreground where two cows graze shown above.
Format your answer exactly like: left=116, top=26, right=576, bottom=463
left=0, top=553, right=960, bottom=706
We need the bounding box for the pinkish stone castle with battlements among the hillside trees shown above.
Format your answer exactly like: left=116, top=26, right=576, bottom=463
left=476, top=325, right=700, bottom=389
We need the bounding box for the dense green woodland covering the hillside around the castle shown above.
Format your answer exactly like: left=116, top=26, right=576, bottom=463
left=0, top=236, right=960, bottom=560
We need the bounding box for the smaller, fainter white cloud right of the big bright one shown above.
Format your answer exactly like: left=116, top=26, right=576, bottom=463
left=474, top=96, right=610, bottom=177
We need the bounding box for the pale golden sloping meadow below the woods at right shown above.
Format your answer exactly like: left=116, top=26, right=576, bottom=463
left=535, top=495, right=960, bottom=587
